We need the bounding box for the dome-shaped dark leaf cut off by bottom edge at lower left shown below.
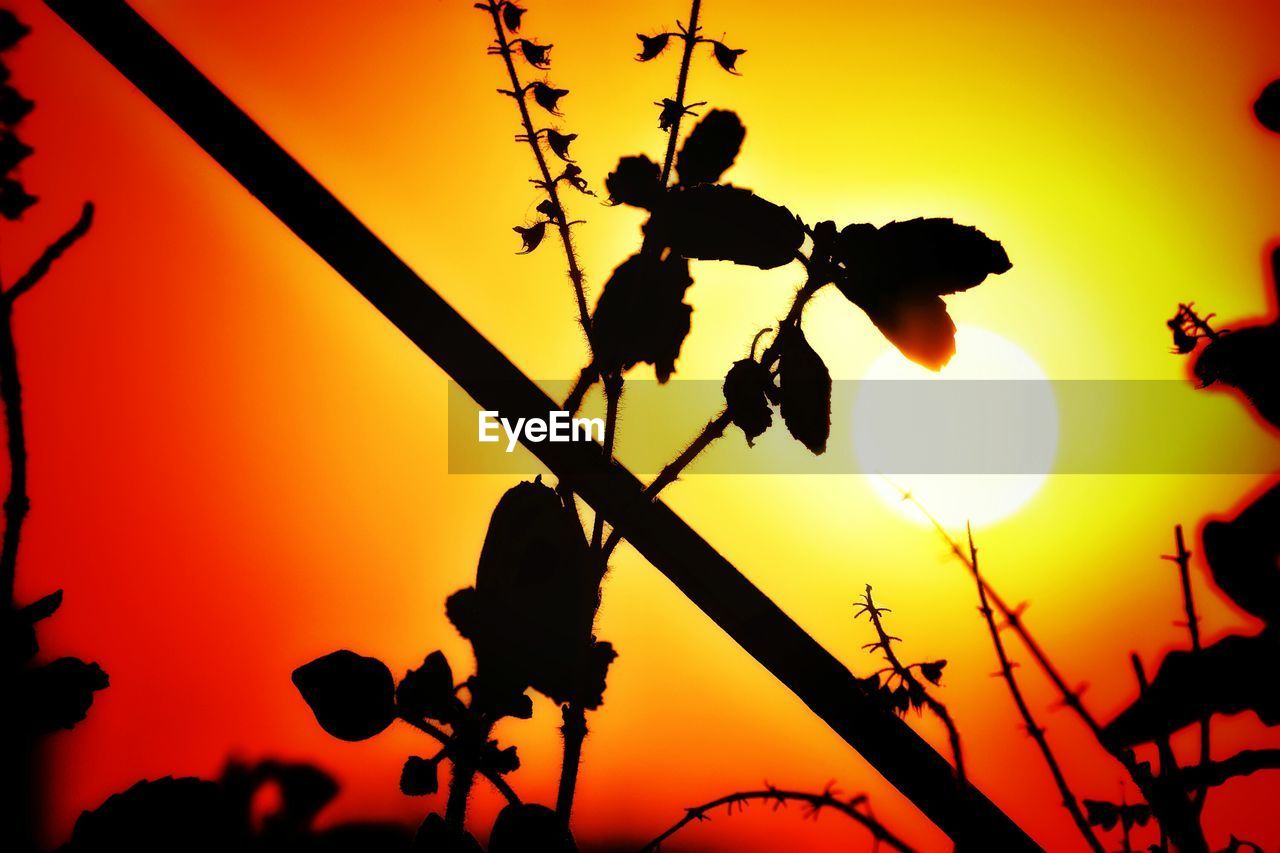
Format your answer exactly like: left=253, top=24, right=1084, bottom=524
left=61, top=776, right=231, bottom=853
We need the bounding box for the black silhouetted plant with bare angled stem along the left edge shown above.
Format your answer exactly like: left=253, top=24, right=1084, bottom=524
left=0, top=9, right=99, bottom=849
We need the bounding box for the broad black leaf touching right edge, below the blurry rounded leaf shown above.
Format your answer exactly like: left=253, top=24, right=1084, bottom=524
left=1105, top=631, right=1280, bottom=747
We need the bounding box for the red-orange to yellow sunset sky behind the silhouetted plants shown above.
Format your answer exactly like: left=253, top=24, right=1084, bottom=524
left=0, top=0, right=1280, bottom=850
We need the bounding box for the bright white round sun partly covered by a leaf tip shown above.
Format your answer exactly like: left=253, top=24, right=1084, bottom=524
left=852, top=327, right=1059, bottom=528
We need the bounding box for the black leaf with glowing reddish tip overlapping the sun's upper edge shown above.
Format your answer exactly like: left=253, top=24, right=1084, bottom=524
left=835, top=219, right=1011, bottom=370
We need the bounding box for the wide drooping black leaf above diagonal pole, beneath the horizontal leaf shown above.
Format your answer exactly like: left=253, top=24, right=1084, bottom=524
left=591, top=252, right=692, bottom=382
